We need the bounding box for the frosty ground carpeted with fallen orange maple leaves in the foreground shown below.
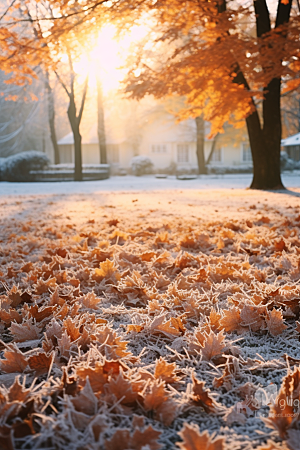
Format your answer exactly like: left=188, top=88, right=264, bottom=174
left=0, top=210, right=300, bottom=450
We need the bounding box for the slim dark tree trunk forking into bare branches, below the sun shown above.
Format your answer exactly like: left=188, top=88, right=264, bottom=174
left=55, top=55, right=88, bottom=181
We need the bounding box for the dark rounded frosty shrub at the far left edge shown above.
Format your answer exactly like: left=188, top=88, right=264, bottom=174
left=0, top=150, right=50, bottom=181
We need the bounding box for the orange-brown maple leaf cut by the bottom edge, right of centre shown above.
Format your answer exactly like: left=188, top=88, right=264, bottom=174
left=176, top=423, right=225, bottom=450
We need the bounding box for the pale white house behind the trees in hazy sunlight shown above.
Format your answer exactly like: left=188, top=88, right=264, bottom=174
left=58, top=113, right=252, bottom=170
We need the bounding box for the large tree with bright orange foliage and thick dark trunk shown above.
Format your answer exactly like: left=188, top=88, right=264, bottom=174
left=0, top=0, right=300, bottom=189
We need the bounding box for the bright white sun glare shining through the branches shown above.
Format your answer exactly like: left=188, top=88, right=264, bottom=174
left=74, top=25, right=148, bottom=94
